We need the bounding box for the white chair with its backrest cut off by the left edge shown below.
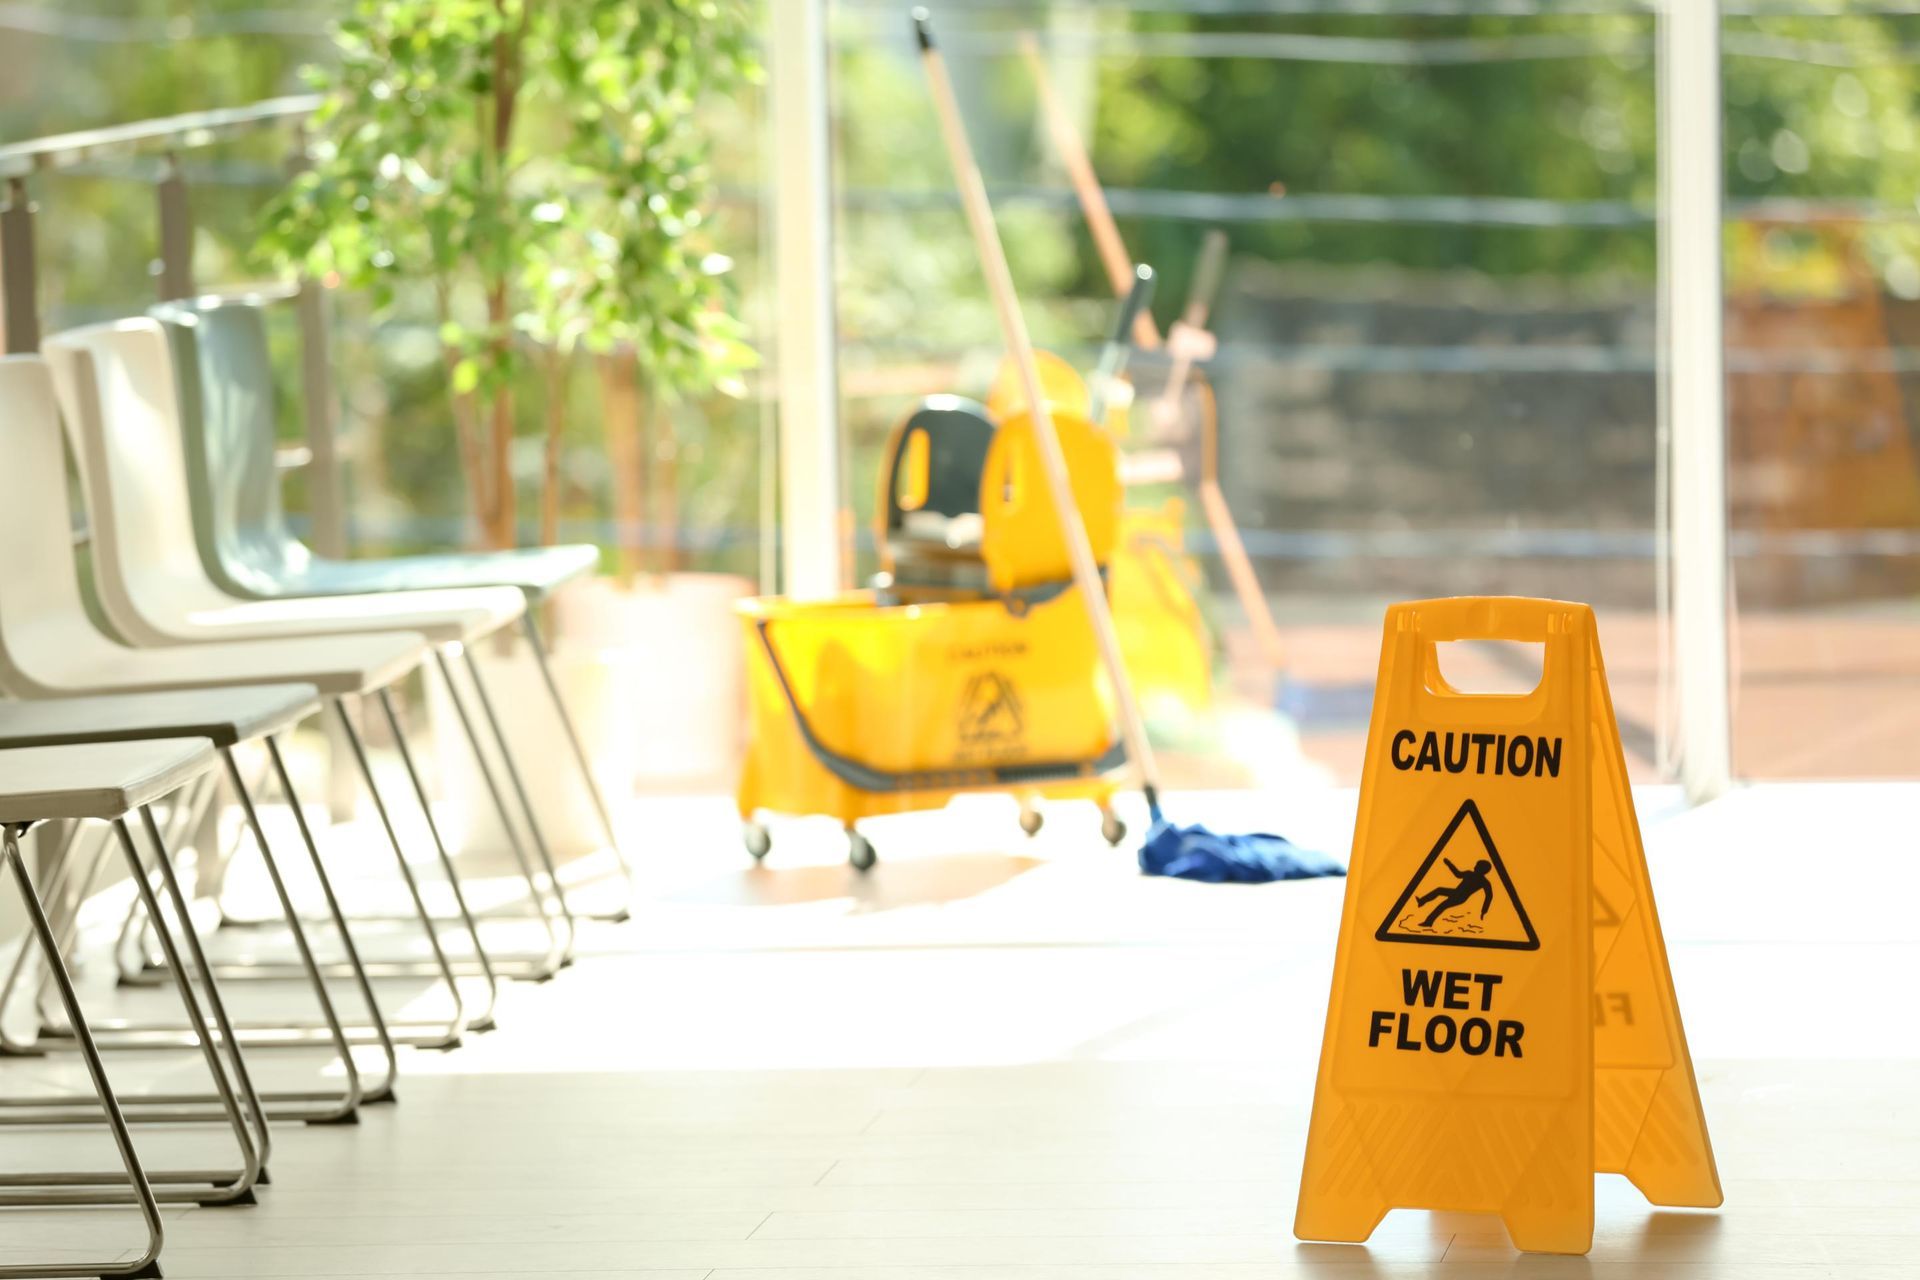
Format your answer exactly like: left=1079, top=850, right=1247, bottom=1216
left=0, top=355, right=493, bottom=1048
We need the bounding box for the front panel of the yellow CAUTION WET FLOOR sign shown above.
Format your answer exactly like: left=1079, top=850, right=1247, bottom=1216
left=1294, top=601, right=1594, bottom=1253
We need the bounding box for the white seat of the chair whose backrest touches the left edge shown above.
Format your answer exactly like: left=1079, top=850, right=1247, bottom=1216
left=27, top=631, right=426, bottom=697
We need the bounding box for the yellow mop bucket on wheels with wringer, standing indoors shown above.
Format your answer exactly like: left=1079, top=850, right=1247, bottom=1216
left=737, top=401, right=1125, bottom=869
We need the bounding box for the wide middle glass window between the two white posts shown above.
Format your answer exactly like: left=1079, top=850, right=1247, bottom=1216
left=833, top=0, right=1663, bottom=785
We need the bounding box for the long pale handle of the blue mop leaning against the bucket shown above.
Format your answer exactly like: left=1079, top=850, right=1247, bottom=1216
left=914, top=10, right=1160, bottom=819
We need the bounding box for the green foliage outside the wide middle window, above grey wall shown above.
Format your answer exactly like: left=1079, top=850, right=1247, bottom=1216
left=1094, top=13, right=1657, bottom=294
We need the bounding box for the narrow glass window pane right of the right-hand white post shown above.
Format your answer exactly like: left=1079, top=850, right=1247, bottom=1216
left=1722, top=6, right=1920, bottom=777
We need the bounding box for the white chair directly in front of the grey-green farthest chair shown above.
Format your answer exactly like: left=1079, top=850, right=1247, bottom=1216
left=42, top=330, right=574, bottom=979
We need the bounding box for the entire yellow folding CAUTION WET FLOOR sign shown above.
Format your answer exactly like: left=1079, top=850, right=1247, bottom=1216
left=1294, top=599, right=1720, bottom=1253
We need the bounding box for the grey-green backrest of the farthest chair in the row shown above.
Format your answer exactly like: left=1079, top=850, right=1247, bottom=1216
left=150, top=294, right=311, bottom=595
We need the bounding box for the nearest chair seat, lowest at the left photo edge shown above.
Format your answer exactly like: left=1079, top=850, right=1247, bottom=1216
left=0, top=739, right=213, bottom=823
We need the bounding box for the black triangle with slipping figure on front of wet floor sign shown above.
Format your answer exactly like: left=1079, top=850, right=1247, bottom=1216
left=1373, top=800, right=1540, bottom=952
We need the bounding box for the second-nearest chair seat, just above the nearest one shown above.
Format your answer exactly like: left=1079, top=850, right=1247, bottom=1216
left=0, top=685, right=321, bottom=750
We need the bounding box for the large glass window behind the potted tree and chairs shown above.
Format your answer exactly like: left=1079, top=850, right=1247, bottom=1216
left=0, top=6, right=772, bottom=581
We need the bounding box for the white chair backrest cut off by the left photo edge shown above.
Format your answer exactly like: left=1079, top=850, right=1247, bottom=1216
left=0, top=355, right=126, bottom=697
